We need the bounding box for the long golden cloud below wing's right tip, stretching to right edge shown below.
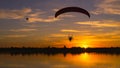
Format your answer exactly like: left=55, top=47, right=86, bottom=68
left=75, top=20, right=120, bottom=27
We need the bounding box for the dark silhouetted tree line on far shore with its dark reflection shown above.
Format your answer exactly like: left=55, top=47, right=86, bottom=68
left=0, top=46, right=120, bottom=56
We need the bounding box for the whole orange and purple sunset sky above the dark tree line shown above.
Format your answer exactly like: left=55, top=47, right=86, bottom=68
left=0, top=0, right=120, bottom=47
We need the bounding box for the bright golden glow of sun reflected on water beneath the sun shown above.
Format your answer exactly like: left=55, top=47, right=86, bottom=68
left=63, top=53, right=95, bottom=66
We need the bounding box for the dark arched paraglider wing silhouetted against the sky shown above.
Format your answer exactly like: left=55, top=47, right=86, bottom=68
left=55, top=7, right=90, bottom=18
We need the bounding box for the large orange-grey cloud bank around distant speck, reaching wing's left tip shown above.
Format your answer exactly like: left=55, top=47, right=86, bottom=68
left=0, top=8, right=60, bottom=23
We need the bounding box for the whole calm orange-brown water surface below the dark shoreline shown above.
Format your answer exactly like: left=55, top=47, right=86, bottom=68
left=0, top=53, right=120, bottom=68
